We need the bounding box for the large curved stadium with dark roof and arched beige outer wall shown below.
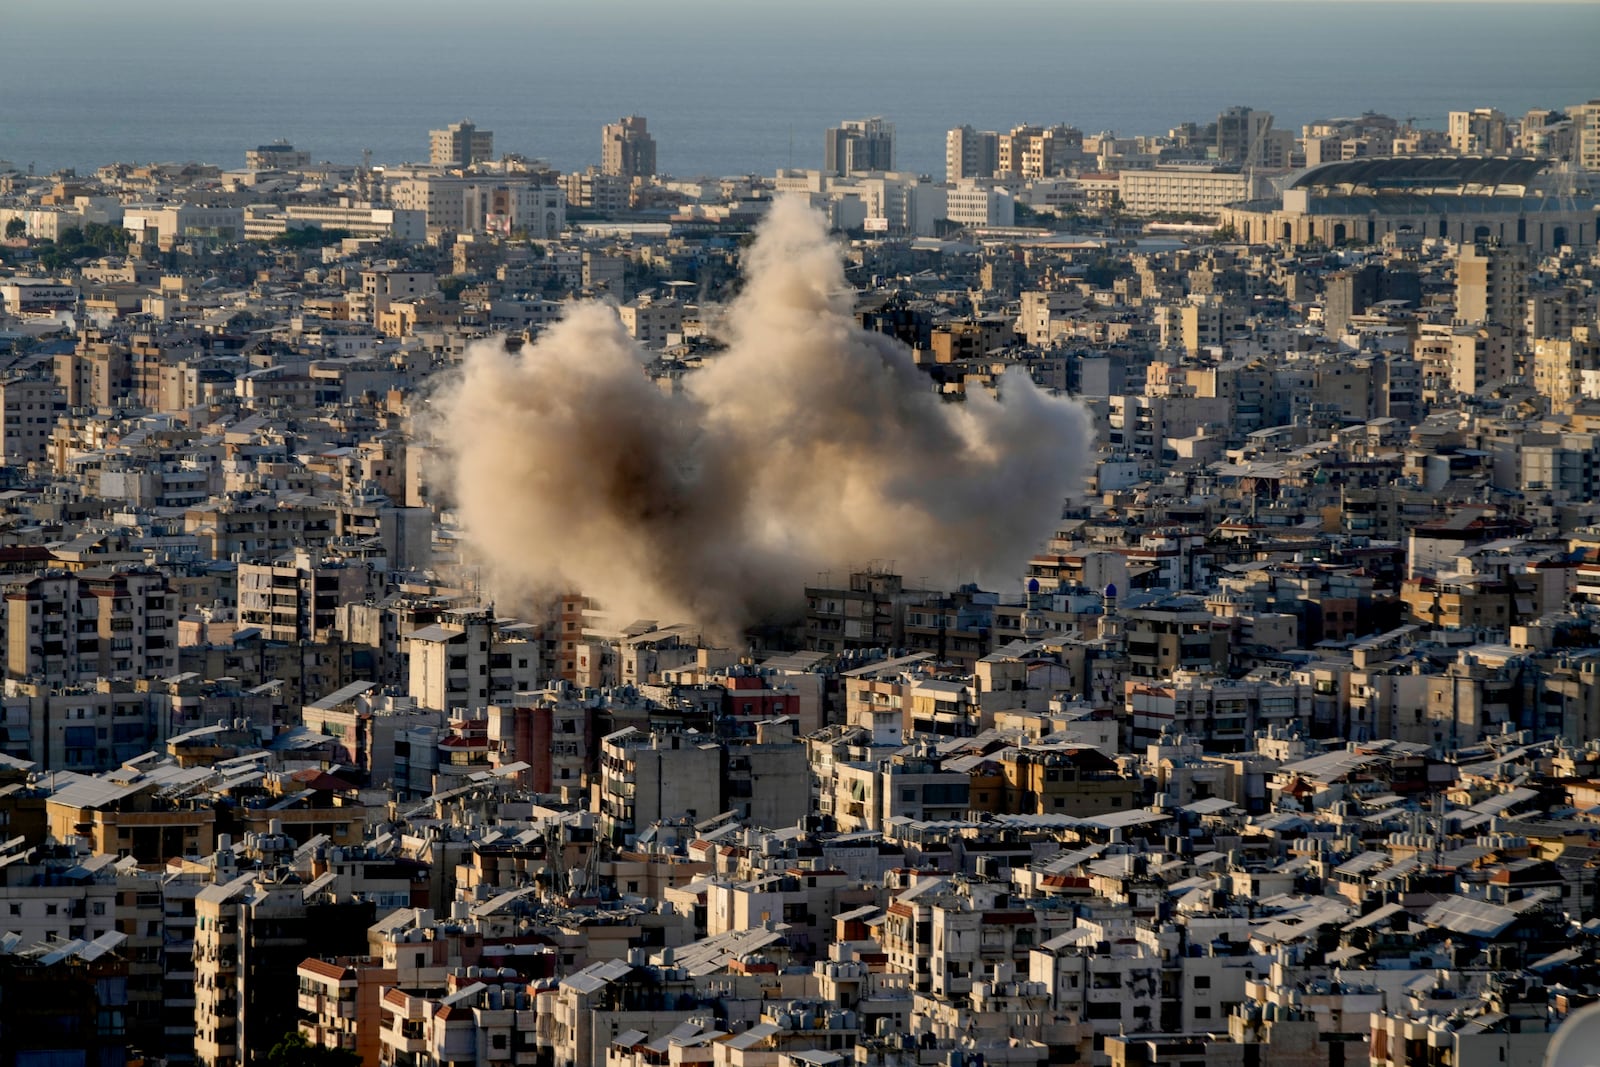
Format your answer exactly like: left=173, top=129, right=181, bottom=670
left=1222, top=155, right=1600, bottom=253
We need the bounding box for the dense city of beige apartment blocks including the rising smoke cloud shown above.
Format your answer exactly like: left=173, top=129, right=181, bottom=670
left=0, top=99, right=1600, bottom=1067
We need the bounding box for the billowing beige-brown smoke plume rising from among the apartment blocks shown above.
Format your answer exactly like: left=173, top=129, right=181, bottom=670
left=432, top=200, right=1090, bottom=635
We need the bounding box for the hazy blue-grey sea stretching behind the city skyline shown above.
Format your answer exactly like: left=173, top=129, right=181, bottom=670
left=0, top=0, right=1600, bottom=178
